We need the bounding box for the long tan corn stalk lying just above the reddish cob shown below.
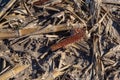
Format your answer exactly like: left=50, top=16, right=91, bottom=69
left=0, top=24, right=77, bottom=39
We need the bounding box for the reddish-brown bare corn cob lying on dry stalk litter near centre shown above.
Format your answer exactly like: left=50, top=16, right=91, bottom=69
left=50, top=28, right=85, bottom=51
